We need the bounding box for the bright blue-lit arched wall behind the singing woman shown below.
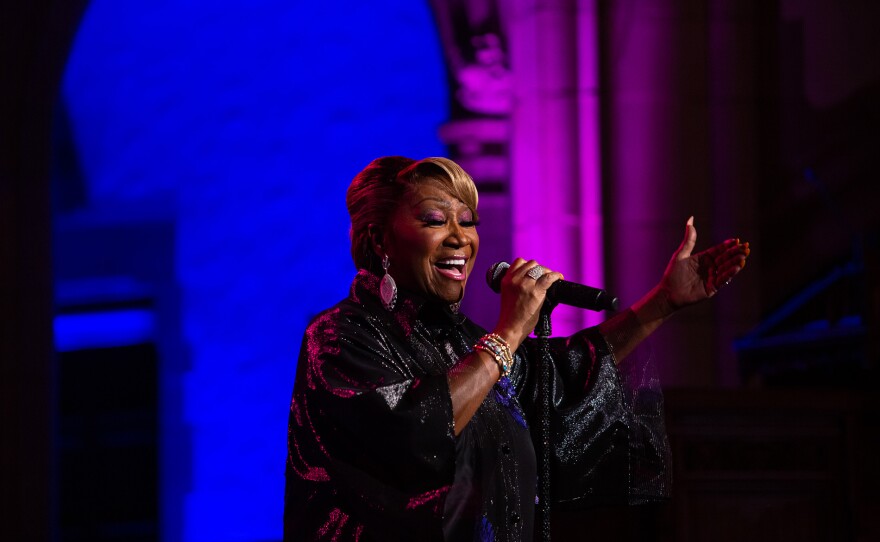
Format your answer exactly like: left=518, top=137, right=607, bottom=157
left=57, top=1, right=447, bottom=542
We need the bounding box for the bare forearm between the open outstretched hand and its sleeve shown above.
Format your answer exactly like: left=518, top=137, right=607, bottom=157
left=599, top=286, right=673, bottom=363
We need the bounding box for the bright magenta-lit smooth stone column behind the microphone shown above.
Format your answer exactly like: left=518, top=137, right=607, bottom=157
left=506, top=0, right=604, bottom=335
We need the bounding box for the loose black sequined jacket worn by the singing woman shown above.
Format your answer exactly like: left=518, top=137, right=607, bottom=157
left=284, top=270, right=668, bottom=542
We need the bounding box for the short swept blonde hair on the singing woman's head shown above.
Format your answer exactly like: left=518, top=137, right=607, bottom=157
left=345, top=156, right=479, bottom=272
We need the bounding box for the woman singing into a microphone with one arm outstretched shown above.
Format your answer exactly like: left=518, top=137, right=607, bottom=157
left=284, top=156, right=749, bottom=542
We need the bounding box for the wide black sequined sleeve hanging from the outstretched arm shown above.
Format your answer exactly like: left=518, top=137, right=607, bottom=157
left=516, top=328, right=670, bottom=506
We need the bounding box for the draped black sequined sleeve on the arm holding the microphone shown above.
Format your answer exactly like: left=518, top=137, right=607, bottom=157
left=285, top=308, right=455, bottom=539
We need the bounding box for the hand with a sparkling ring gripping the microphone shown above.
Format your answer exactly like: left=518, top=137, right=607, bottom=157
left=494, top=258, right=563, bottom=350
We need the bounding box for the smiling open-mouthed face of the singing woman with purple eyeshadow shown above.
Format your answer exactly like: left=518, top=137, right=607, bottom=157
left=382, top=181, right=480, bottom=303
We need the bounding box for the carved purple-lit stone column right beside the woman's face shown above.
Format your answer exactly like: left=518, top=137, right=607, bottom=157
left=431, top=0, right=513, bottom=329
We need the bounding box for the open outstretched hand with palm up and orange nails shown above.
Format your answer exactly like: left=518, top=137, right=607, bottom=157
left=660, top=217, right=750, bottom=313
